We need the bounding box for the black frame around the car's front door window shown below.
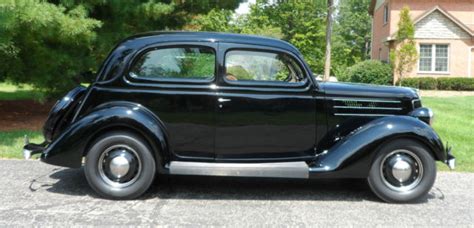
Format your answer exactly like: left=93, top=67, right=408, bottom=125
left=220, top=47, right=310, bottom=88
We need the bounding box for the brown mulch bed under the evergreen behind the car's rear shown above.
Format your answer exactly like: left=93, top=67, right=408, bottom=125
left=0, top=100, right=54, bottom=131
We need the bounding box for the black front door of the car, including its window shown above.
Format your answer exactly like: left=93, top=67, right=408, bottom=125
left=215, top=43, right=316, bottom=161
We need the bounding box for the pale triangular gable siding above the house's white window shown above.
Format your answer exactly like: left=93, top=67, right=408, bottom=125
left=415, top=10, right=471, bottom=39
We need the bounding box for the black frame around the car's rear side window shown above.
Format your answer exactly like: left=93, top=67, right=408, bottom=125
left=125, top=42, right=218, bottom=84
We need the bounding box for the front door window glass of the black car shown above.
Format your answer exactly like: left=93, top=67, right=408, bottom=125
left=225, top=50, right=304, bottom=83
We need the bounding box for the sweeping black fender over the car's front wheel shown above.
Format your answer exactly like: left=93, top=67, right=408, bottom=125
left=310, top=116, right=447, bottom=177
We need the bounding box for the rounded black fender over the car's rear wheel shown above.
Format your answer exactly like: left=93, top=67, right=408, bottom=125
left=41, top=102, right=168, bottom=168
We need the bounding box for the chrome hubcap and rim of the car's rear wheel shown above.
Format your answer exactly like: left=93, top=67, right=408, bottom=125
left=98, top=145, right=142, bottom=188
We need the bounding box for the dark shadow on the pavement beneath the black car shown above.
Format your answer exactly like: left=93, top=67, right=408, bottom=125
left=30, top=168, right=440, bottom=203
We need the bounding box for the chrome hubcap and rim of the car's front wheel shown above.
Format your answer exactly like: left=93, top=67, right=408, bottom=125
left=380, top=150, right=423, bottom=192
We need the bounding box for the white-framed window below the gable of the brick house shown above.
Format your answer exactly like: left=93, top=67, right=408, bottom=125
left=418, top=44, right=449, bottom=72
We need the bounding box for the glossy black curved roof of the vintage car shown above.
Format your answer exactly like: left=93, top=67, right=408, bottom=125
left=122, top=31, right=300, bottom=54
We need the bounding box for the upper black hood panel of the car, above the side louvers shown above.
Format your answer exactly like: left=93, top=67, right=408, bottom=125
left=319, top=82, right=419, bottom=100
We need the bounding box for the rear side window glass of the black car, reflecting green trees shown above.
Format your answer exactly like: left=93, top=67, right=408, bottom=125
left=130, top=47, right=216, bottom=80
